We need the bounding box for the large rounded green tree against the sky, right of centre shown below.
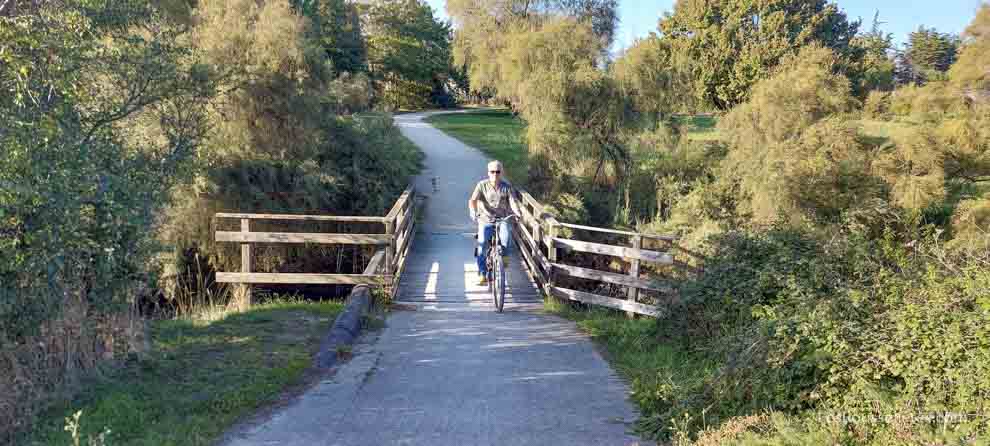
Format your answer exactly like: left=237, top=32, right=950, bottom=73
left=659, top=0, right=859, bottom=110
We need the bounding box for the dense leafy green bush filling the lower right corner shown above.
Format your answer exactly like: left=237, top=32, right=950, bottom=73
left=647, top=229, right=990, bottom=444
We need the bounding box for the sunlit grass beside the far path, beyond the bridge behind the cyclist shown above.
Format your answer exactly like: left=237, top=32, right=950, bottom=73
left=426, top=110, right=528, bottom=185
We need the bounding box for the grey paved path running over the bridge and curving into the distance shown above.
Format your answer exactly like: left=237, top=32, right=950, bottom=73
left=220, top=110, right=644, bottom=446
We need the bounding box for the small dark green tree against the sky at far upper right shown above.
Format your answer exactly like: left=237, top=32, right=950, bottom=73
left=897, top=26, right=959, bottom=84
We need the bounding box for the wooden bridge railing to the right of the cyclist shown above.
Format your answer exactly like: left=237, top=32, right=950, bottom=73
left=514, top=191, right=694, bottom=316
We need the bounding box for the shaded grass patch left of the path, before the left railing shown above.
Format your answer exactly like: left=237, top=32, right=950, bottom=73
left=25, top=301, right=343, bottom=446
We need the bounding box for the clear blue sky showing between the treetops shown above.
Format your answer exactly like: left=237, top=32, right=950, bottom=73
left=427, top=0, right=983, bottom=50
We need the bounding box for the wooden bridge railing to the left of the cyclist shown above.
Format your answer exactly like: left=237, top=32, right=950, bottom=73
left=215, top=185, right=417, bottom=302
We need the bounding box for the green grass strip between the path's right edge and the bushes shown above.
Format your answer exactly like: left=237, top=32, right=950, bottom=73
left=544, top=299, right=715, bottom=437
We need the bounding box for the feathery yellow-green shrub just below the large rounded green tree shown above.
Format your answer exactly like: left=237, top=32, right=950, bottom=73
left=719, top=45, right=882, bottom=224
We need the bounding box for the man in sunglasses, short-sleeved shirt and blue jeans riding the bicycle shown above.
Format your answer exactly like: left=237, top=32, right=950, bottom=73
left=468, top=161, right=520, bottom=285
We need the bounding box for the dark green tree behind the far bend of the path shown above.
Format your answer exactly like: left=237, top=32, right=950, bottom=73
left=362, top=0, right=452, bottom=109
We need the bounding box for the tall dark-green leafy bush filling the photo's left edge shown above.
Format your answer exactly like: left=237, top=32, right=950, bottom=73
left=0, top=2, right=211, bottom=442
